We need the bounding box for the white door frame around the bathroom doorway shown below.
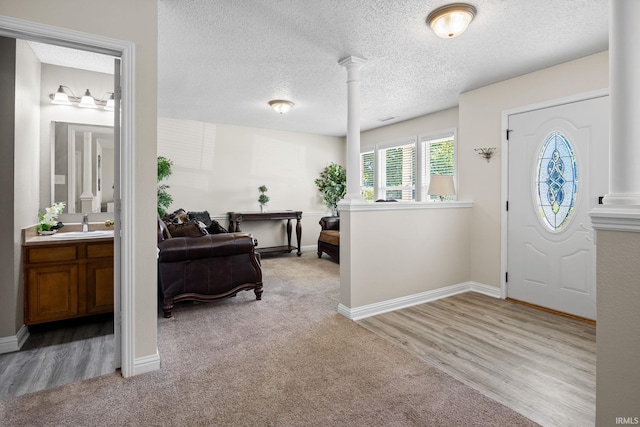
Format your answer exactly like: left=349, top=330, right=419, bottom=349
left=0, top=16, right=135, bottom=377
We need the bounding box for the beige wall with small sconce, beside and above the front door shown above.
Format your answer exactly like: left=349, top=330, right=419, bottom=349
left=458, top=52, right=609, bottom=287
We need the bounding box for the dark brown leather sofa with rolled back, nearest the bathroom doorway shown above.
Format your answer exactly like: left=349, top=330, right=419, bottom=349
left=158, top=217, right=262, bottom=317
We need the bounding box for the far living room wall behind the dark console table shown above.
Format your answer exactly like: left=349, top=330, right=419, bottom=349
left=158, top=118, right=345, bottom=248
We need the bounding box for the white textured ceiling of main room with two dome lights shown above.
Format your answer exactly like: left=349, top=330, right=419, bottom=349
left=31, top=0, right=609, bottom=136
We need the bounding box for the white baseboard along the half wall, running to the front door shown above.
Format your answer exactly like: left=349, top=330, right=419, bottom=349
left=338, top=282, right=500, bottom=320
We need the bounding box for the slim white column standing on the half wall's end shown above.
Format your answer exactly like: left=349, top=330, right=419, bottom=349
left=338, top=56, right=367, bottom=202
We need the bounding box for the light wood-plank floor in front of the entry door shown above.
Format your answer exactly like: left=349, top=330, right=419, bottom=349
left=358, top=292, right=596, bottom=427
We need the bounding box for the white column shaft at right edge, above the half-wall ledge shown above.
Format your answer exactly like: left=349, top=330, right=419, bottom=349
left=604, top=0, right=640, bottom=205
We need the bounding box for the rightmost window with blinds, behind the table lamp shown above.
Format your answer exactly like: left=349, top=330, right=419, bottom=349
left=420, top=131, right=456, bottom=200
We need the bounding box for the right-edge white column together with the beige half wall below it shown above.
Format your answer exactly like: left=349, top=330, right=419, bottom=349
left=591, top=0, right=640, bottom=426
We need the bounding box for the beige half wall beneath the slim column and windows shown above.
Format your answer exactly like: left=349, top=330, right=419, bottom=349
left=340, top=203, right=471, bottom=309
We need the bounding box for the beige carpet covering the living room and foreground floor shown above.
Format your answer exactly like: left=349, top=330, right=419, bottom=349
left=0, top=251, right=536, bottom=426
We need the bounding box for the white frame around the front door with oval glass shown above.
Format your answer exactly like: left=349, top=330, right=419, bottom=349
left=500, top=88, right=609, bottom=299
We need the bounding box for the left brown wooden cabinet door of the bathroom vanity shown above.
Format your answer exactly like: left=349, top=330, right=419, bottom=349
left=25, top=264, right=78, bottom=325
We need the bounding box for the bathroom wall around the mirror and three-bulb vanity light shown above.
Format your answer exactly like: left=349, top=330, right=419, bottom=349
left=35, top=64, right=113, bottom=214
